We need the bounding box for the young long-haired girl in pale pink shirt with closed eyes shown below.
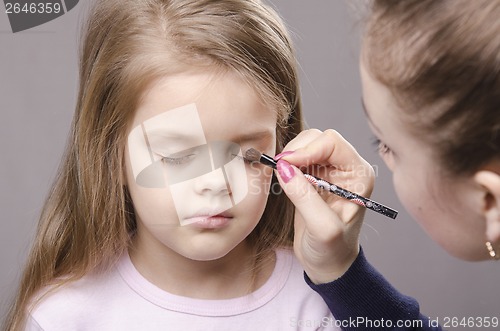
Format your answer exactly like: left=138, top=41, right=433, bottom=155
left=6, top=0, right=373, bottom=331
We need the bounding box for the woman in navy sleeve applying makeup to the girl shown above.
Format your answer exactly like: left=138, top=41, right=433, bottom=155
left=281, top=0, right=500, bottom=330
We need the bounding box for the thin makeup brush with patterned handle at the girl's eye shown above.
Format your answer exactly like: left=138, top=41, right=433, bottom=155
left=244, top=148, right=398, bottom=219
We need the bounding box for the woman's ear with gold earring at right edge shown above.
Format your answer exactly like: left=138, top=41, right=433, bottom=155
left=474, top=169, right=500, bottom=245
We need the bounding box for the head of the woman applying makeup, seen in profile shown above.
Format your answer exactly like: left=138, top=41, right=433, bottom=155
left=361, top=0, right=500, bottom=259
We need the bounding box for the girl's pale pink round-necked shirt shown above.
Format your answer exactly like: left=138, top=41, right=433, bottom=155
left=26, top=250, right=340, bottom=331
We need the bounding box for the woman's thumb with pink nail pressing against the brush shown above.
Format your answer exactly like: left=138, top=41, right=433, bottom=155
left=276, top=160, right=341, bottom=229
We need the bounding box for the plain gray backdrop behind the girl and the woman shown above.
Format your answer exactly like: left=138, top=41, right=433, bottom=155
left=0, top=0, right=500, bottom=330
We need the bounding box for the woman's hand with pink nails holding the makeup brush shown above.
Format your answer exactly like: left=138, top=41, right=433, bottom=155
left=277, top=129, right=375, bottom=284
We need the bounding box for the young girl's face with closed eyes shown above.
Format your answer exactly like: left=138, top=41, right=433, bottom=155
left=126, top=70, right=277, bottom=261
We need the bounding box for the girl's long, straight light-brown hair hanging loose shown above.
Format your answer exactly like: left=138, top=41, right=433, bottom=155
left=6, top=0, right=302, bottom=330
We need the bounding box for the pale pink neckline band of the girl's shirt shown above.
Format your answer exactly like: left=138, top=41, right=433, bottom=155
left=117, top=249, right=292, bottom=316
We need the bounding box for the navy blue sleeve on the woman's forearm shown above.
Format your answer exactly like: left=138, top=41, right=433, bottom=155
left=304, top=249, right=442, bottom=331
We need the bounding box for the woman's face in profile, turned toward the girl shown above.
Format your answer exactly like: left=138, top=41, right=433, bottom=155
left=360, top=63, right=486, bottom=260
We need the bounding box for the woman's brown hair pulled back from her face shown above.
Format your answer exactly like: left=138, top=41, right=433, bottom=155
left=363, top=0, right=500, bottom=175
